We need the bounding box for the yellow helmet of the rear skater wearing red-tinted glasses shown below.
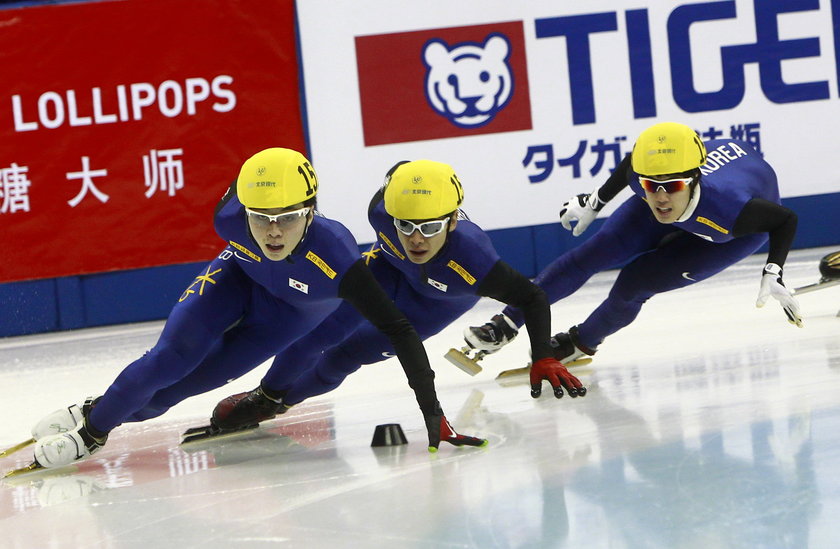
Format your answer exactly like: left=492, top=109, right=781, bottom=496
left=631, top=122, right=706, bottom=175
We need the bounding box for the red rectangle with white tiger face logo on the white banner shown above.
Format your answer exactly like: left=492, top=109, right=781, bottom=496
left=355, top=21, right=531, bottom=147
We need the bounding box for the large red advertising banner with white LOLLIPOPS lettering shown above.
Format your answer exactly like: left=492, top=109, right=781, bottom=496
left=0, top=0, right=306, bottom=282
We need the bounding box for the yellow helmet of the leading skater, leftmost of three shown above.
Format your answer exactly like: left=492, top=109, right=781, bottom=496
left=236, top=147, right=318, bottom=208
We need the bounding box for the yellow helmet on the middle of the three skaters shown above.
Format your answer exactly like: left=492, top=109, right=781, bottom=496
left=385, top=160, right=464, bottom=219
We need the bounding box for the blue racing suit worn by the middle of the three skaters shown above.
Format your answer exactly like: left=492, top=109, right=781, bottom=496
left=262, top=190, right=551, bottom=404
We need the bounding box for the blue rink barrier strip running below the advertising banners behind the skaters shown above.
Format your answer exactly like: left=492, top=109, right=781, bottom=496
left=0, top=193, right=840, bottom=337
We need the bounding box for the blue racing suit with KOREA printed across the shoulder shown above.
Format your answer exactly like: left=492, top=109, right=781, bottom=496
left=504, top=139, right=796, bottom=349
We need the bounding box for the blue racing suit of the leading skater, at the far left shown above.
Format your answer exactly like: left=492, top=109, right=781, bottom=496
left=90, top=186, right=441, bottom=432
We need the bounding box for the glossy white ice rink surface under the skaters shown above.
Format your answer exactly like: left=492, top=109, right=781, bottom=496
left=0, top=248, right=840, bottom=549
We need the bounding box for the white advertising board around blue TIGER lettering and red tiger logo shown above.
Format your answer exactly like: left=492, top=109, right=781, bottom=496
left=298, top=0, right=840, bottom=242
